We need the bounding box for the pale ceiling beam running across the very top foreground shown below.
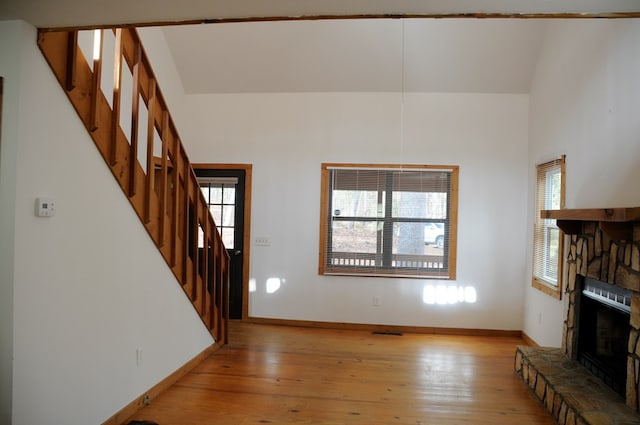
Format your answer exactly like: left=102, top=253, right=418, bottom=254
left=0, top=0, right=640, bottom=29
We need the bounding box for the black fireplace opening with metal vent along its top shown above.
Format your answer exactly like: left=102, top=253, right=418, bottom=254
left=577, top=278, right=631, bottom=397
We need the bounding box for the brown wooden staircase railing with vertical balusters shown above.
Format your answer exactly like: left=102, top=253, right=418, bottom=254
left=38, top=28, right=229, bottom=344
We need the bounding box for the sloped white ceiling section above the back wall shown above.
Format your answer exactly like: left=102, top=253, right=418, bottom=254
left=163, top=19, right=547, bottom=93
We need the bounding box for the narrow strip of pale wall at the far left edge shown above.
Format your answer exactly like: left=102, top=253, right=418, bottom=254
left=0, top=21, right=22, bottom=424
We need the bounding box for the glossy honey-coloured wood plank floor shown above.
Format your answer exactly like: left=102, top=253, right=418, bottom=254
left=126, top=322, right=554, bottom=425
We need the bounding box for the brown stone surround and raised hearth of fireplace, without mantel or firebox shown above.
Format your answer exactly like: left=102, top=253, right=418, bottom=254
left=515, top=221, right=640, bottom=425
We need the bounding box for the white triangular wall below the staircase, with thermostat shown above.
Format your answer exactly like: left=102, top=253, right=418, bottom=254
left=0, top=24, right=212, bottom=425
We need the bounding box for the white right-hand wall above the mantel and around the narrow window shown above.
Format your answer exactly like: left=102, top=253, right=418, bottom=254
left=524, top=20, right=640, bottom=346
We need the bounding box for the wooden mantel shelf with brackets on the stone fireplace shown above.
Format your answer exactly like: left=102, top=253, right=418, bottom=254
left=540, top=207, right=640, bottom=240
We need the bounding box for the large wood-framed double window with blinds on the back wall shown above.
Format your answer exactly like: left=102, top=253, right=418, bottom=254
left=319, top=164, right=458, bottom=279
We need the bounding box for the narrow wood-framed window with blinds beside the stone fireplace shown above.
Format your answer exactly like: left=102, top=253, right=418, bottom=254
left=532, top=155, right=565, bottom=299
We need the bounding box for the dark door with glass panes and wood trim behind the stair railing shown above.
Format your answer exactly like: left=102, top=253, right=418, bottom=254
left=195, top=168, right=246, bottom=319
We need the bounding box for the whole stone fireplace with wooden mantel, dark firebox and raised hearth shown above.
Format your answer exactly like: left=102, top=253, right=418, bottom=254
left=515, top=208, right=640, bottom=425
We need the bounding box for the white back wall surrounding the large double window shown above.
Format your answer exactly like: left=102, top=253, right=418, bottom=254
left=179, top=88, right=528, bottom=329
